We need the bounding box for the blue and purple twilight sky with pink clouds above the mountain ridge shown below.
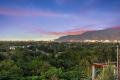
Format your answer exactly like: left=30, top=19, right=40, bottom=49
left=0, top=0, right=120, bottom=40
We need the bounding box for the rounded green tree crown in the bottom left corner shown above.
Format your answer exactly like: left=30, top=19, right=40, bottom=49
left=0, top=60, right=22, bottom=80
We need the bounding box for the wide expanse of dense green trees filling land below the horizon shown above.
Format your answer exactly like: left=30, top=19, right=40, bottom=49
left=0, top=41, right=117, bottom=80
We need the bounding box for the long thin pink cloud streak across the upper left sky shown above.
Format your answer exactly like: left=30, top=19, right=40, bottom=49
left=0, top=7, right=60, bottom=16
